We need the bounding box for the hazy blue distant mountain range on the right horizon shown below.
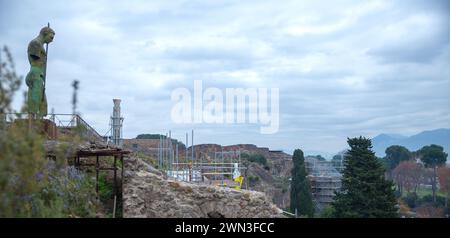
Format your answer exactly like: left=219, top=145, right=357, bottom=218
left=372, top=129, right=450, bottom=157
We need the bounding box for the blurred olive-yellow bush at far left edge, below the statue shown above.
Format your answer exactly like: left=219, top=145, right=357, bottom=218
left=0, top=122, right=47, bottom=217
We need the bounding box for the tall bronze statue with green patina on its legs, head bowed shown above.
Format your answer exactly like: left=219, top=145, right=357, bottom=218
left=25, top=27, right=55, bottom=118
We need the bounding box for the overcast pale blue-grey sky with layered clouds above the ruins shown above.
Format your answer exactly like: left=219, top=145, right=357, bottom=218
left=0, top=0, right=450, bottom=156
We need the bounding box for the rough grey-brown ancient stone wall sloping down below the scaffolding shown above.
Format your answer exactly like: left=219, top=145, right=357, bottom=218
left=123, top=158, right=283, bottom=218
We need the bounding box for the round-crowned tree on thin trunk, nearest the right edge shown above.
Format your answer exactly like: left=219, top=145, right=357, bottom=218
left=419, top=144, right=447, bottom=202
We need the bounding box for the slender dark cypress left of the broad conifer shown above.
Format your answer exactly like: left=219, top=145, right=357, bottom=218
left=291, top=149, right=314, bottom=217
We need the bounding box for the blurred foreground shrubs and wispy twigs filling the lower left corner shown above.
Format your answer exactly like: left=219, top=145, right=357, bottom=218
left=0, top=47, right=96, bottom=217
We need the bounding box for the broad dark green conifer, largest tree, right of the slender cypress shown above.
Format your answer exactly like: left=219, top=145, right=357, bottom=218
left=332, top=137, right=397, bottom=218
